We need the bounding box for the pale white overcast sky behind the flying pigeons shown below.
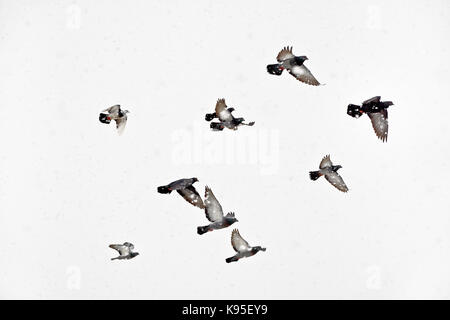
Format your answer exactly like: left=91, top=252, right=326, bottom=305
left=0, top=0, right=450, bottom=299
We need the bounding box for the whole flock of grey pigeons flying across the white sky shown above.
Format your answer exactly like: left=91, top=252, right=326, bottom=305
left=99, top=47, right=393, bottom=263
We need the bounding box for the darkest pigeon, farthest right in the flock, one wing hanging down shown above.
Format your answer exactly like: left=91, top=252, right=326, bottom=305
left=347, top=96, right=394, bottom=142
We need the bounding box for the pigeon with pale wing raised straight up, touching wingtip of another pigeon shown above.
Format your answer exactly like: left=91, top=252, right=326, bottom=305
left=197, top=186, right=238, bottom=234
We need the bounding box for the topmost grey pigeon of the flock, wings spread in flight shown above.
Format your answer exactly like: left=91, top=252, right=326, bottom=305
left=267, top=47, right=320, bottom=86
